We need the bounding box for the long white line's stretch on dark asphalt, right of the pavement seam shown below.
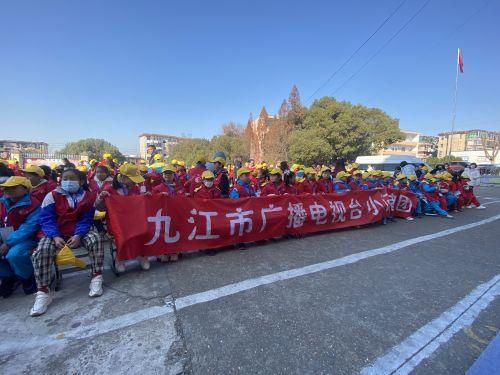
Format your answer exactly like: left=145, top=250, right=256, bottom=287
left=175, top=215, right=500, bottom=310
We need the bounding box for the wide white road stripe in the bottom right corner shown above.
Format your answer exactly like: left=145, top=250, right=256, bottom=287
left=361, top=275, right=500, bottom=375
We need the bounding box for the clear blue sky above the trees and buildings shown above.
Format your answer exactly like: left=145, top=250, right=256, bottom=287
left=0, top=0, right=500, bottom=153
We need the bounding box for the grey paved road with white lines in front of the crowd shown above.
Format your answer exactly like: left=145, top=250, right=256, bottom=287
left=0, top=188, right=500, bottom=374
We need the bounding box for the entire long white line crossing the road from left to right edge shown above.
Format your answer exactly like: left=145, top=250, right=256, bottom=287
left=0, top=215, right=500, bottom=356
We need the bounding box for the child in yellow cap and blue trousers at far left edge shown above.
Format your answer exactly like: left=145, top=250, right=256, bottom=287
left=0, top=176, right=40, bottom=298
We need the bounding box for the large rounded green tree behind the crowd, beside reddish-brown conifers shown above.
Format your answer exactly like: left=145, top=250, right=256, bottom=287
left=290, top=97, right=403, bottom=163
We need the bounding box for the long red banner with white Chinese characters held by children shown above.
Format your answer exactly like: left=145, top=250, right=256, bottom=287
left=106, top=189, right=417, bottom=260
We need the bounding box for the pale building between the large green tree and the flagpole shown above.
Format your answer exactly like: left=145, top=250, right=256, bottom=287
left=378, top=130, right=438, bottom=159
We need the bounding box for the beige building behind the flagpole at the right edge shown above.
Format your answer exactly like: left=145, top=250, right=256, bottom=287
left=438, top=129, right=500, bottom=158
